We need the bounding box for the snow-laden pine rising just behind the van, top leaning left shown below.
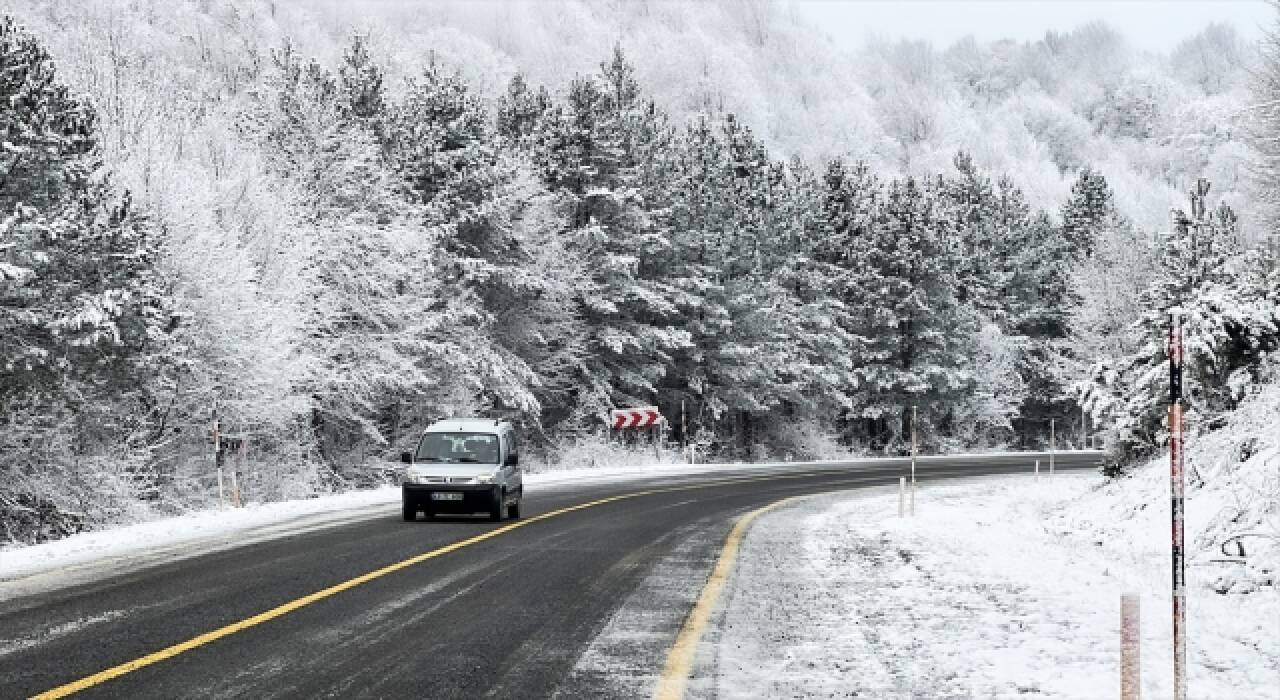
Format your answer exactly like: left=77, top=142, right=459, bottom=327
left=389, top=58, right=601, bottom=432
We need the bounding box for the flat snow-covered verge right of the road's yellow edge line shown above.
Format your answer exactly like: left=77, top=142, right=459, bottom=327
left=706, top=473, right=1280, bottom=699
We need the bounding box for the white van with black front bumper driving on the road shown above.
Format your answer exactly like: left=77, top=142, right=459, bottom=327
left=401, top=418, right=524, bottom=521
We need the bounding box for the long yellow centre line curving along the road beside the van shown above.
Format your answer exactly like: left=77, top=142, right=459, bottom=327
left=33, top=471, right=832, bottom=700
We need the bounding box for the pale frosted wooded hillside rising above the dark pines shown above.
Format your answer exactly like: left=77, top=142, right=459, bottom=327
left=0, top=0, right=1257, bottom=235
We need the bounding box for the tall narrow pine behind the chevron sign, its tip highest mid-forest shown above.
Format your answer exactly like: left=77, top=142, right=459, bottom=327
left=529, top=49, right=687, bottom=426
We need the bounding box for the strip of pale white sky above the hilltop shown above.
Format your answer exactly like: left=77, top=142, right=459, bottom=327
left=791, top=0, right=1277, bottom=51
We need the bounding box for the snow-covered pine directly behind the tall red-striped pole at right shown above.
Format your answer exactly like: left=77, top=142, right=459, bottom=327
left=1082, top=180, right=1280, bottom=457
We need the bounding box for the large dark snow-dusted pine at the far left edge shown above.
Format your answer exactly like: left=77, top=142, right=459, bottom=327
left=0, top=19, right=178, bottom=537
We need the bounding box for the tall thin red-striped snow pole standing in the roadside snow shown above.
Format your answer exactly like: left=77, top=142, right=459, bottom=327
left=1169, top=311, right=1187, bottom=700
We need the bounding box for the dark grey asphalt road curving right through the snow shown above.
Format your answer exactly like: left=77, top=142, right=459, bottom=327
left=0, top=453, right=1097, bottom=699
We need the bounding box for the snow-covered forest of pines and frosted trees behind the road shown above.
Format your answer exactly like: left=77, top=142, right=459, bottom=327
left=0, top=0, right=1280, bottom=541
